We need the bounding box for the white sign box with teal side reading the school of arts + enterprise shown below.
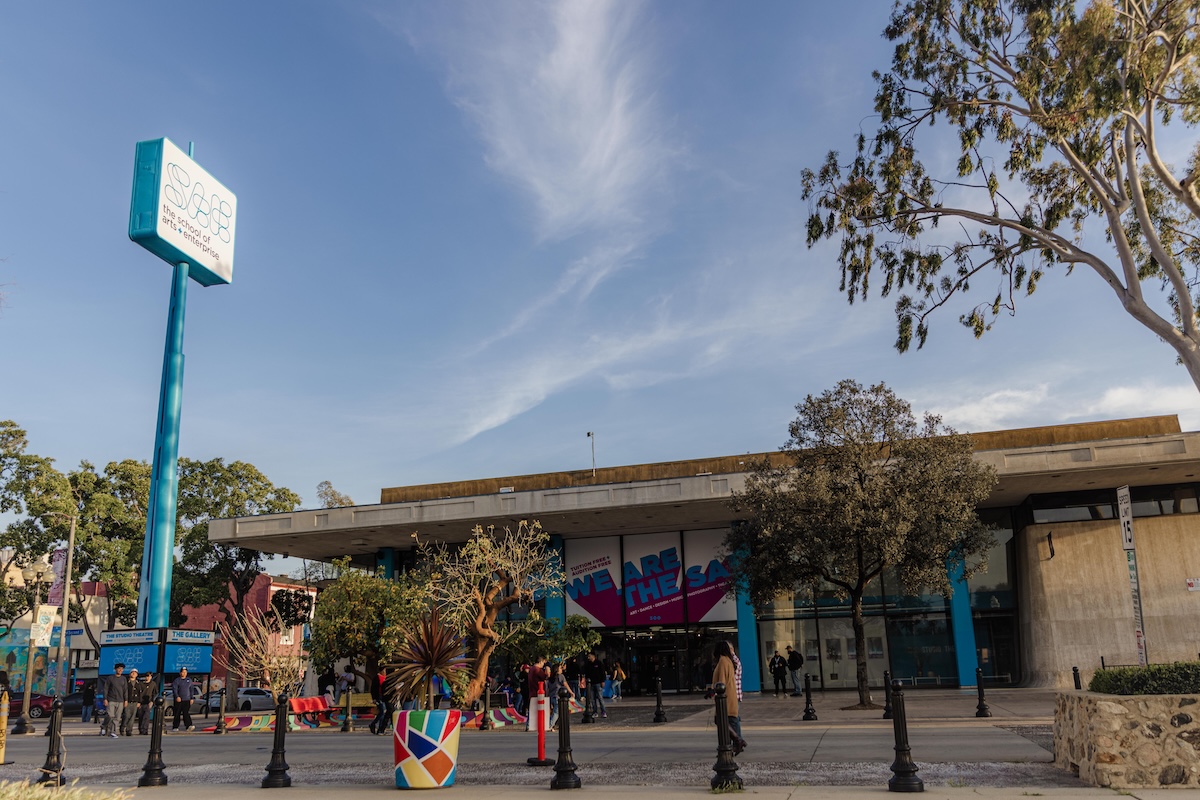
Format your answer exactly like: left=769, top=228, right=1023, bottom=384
left=130, top=139, right=238, bottom=287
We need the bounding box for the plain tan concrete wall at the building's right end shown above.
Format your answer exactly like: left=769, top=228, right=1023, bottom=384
left=1019, top=515, right=1200, bottom=688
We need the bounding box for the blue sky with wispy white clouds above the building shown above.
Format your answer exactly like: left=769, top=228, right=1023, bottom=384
left=0, top=0, right=1200, bottom=505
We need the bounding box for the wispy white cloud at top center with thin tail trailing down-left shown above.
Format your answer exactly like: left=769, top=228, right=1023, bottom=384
left=406, top=0, right=680, bottom=355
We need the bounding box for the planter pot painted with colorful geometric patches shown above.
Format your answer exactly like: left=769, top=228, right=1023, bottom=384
left=392, top=709, right=462, bottom=789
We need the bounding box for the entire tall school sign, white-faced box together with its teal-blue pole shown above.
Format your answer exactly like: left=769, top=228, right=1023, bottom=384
left=130, top=139, right=238, bottom=628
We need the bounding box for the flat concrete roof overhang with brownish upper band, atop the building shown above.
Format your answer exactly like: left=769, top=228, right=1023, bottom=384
left=209, top=416, right=1200, bottom=564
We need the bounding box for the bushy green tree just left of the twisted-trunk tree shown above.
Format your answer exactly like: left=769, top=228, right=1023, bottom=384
left=306, top=558, right=430, bottom=686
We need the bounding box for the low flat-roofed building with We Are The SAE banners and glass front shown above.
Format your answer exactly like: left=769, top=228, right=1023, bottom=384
left=209, top=416, right=1200, bottom=691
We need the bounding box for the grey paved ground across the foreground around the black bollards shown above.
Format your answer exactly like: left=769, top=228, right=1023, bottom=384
left=0, top=690, right=1080, bottom=800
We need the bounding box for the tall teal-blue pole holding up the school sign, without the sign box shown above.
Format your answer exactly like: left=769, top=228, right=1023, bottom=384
left=138, top=261, right=188, bottom=628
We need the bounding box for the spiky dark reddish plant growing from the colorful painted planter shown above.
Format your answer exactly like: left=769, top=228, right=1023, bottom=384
left=388, top=607, right=468, bottom=709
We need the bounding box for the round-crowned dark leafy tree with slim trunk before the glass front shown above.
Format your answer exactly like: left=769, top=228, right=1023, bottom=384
left=725, top=380, right=996, bottom=706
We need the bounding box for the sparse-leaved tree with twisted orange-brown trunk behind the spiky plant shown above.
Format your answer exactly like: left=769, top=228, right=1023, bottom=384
left=421, top=519, right=564, bottom=703
